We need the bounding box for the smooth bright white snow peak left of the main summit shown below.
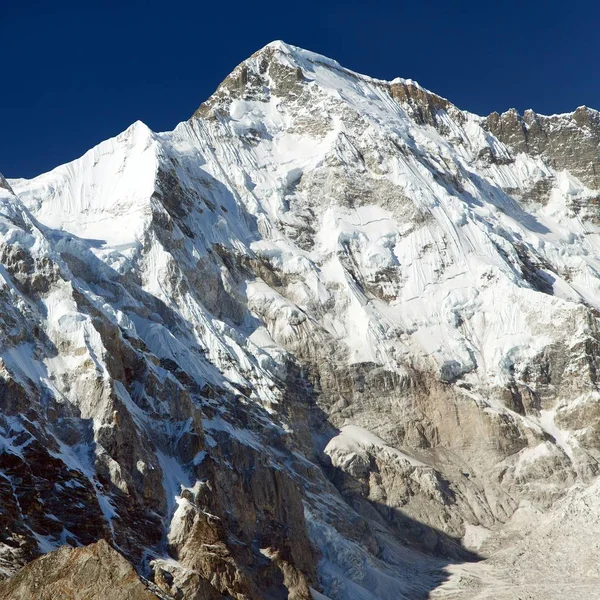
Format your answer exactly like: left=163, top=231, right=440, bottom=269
left=13, top=121, right=158, bottom=249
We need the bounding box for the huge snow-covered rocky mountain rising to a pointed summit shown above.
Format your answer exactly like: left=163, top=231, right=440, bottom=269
left=0, top=42, right=600, bottom=600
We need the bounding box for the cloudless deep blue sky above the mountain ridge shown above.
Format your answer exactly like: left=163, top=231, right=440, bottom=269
left=0, top=0, right=600, bottom=177
